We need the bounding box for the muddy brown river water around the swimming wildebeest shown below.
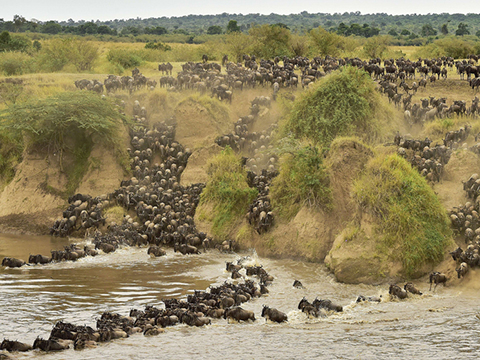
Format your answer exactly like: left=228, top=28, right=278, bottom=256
left=0, top=234, right=480, bottom=359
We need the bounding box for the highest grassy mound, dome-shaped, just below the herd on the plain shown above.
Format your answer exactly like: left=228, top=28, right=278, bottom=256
left=283, top=66, right=394, bottom=145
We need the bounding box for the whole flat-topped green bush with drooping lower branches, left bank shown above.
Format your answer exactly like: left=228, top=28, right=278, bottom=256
left=0, top=91, right=128, bottom=196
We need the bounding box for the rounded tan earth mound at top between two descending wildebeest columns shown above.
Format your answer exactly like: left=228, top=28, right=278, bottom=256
left=175, top=97, right=233, bottom=149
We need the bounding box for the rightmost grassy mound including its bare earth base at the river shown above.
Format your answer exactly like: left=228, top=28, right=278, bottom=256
left=326, top=155, right=452, bottom=282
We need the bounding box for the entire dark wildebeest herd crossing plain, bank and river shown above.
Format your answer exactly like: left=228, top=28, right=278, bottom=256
left=0, top=52, right=480, bottom=358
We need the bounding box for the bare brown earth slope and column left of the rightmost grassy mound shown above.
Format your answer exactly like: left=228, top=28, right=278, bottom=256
left=237, top=138, right=373, bottom=261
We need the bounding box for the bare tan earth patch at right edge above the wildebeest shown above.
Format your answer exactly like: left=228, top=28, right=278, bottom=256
left=433, top=150, right=480, bottom=210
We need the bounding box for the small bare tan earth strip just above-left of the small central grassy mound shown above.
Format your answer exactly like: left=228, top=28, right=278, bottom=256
left=180, top=144, right=222, bottom=186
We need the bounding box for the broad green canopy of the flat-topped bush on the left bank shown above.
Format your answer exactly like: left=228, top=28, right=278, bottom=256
left=0, top=91, right=124, bottom=171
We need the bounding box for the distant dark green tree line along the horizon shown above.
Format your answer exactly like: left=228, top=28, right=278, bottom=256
left=0, top=11, right=480, bottom=40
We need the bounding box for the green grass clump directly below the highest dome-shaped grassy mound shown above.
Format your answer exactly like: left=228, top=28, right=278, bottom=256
left=270, top=146, right=333, bottom=219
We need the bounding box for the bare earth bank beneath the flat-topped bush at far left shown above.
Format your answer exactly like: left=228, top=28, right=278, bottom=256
left=0, top=142, right=126, bottom=235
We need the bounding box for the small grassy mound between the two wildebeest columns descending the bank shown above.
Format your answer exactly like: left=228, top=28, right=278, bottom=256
left=196, top=147, right=258, bottom=240
